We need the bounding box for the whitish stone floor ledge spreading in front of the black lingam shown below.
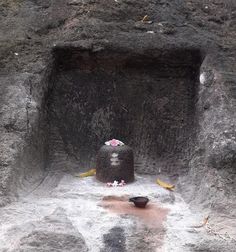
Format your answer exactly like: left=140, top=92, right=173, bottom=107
left=0, top=172, right=236, bottom=252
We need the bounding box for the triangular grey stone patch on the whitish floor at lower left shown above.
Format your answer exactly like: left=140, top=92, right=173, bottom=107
left=8, top=208, right=88, bottom=252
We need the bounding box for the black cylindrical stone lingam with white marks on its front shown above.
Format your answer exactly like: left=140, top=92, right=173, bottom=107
left=96, top=140, right=134, bottom=183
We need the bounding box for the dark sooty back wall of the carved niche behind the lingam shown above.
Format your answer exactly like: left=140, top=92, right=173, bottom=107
left=48, top=48, right=201, bottom=174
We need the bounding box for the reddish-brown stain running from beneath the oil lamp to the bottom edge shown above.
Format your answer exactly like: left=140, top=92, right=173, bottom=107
left=100, top=195, right=169, bottom=252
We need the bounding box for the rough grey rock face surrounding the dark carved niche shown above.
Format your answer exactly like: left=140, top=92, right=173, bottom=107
left=0, top=0, right=236, bottom=251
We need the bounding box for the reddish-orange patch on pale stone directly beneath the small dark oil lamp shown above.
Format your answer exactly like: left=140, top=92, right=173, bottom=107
left=101, top=196, right=169, bottom=229
